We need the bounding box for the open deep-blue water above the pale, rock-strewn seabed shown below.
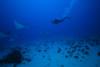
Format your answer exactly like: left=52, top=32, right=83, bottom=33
left=0, top=0, right=100, bottom=67
